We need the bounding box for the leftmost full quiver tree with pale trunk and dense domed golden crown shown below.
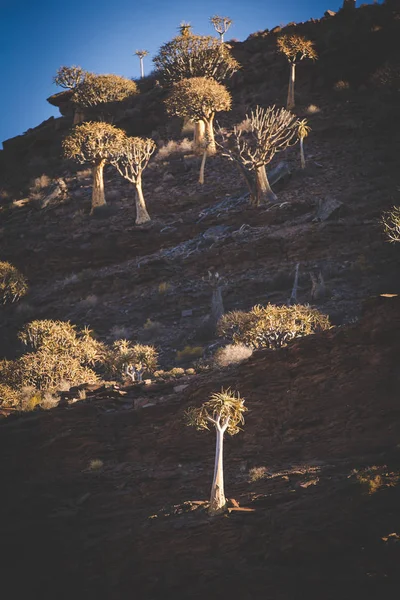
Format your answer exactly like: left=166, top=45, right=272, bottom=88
left=63, top=121, right=126, bottom=213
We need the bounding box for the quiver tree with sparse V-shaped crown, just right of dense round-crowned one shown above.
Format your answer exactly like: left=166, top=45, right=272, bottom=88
left=112, top=137, right=156, bottom=225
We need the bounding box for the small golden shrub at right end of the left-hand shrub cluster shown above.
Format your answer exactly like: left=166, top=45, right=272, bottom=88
left=104, top=340, right=158, bottom=377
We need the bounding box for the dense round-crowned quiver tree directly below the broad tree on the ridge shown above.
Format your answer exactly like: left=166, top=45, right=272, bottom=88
left=165, top=77, right=232, bottom=164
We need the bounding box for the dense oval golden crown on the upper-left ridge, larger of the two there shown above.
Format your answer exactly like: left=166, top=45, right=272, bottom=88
left=72, top=73, right=138, bottom=120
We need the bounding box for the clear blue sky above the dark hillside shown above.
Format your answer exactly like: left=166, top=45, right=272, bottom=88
left=0, top=0, right=368, bottom=142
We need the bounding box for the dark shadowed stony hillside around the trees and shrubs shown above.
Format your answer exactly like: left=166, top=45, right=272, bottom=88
left=0, top=6, right=400, bottom=600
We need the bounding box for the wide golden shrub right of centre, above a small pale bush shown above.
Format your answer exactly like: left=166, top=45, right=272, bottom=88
left=218, top=304, right=330, bottom=348
